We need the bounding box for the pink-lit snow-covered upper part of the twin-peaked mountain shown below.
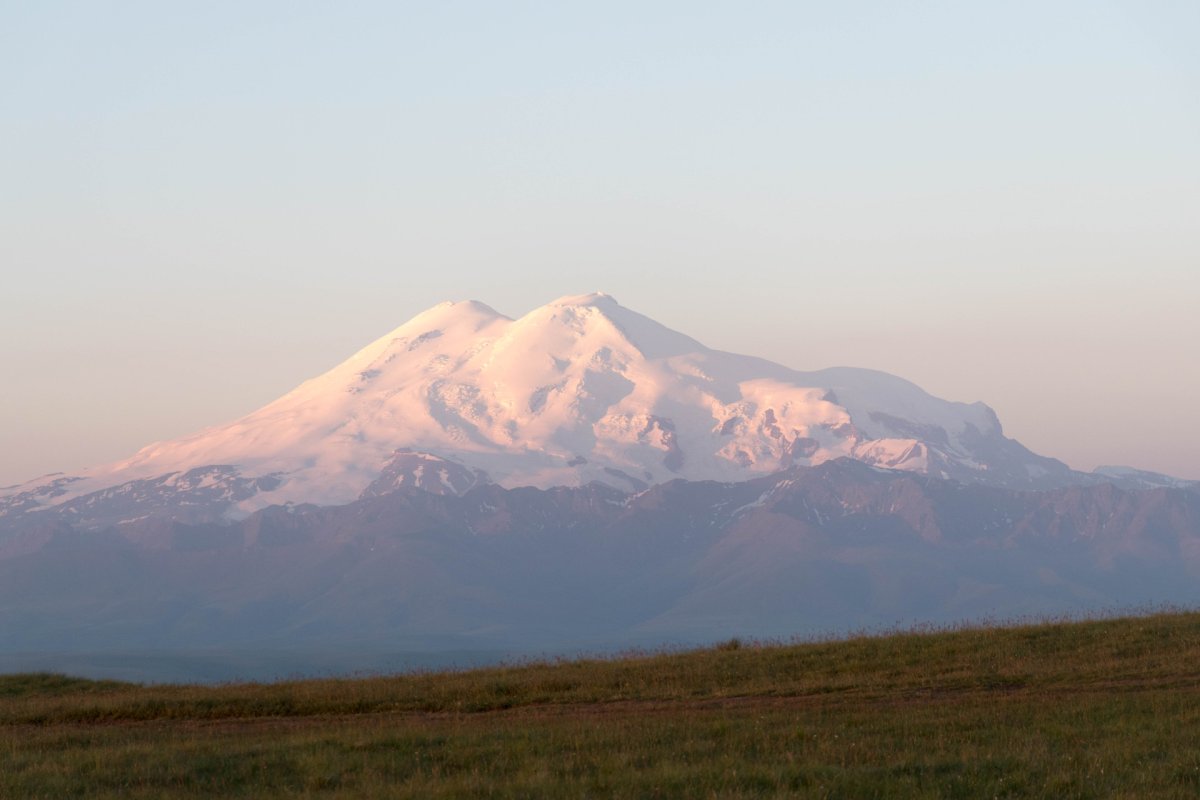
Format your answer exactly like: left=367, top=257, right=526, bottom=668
left=0, top=294, right=1090, bottom=525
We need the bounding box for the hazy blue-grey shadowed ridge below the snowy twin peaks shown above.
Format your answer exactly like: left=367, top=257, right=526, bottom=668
left=0, top=459, right=1200, bottom=651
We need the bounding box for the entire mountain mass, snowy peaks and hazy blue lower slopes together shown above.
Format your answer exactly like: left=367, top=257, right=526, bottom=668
left=0, top=293, right=1200, bottom=678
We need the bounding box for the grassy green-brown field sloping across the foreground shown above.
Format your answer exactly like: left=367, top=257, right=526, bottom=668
left=0, top=613, right=1200, bottom=798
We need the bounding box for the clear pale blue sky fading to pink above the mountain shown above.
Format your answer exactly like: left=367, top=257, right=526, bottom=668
left=0, top=0, right=1200, bottom=485
